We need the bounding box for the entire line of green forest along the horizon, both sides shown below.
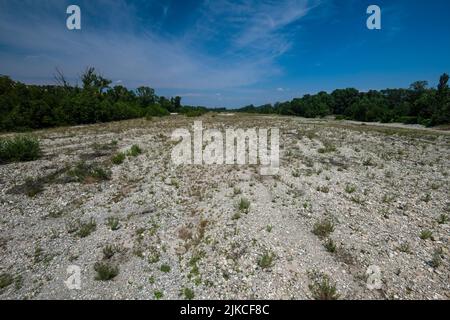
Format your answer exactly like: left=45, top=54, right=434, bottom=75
left=0, top=68, right=450, bottom=131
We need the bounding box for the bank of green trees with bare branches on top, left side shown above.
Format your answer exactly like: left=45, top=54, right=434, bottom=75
left=0, top=68, right=182, bottom=131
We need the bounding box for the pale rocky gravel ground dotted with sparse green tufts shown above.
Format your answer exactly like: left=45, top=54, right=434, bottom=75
left=0, top=114, right=450, bottom=299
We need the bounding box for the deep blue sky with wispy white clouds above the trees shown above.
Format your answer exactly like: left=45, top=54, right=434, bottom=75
left=0, top=0, right=450, bottom=107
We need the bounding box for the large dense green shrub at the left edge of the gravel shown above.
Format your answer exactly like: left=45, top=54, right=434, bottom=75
left=0, top=136, right=41, bottom=163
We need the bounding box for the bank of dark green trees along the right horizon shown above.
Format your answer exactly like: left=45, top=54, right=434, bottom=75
left=239, top=74, right=450, bottom=126
